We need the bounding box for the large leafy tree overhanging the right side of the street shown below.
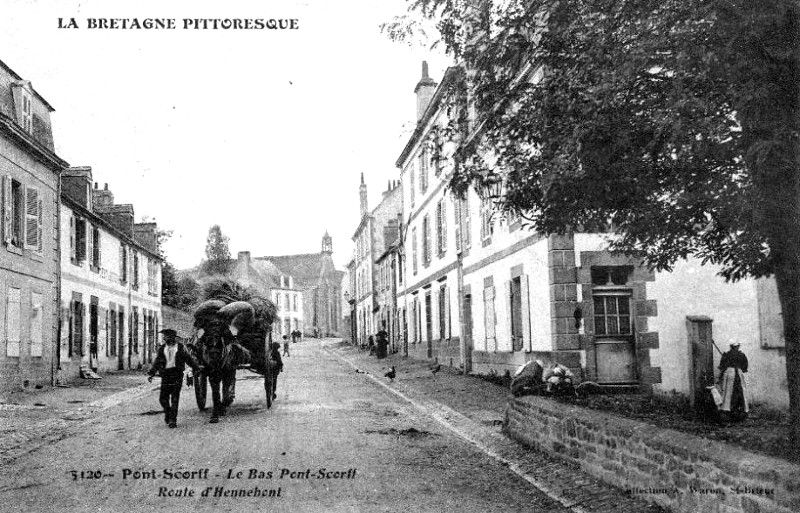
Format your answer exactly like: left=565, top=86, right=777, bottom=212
left=392, top=0, right=800, bottom=458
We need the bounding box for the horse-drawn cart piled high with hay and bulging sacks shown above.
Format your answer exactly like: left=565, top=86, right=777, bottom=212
left=192, top=279, right=277, bottom=410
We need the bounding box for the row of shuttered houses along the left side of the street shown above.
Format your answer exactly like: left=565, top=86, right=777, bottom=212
left=0, top=61, right=162, bottom=390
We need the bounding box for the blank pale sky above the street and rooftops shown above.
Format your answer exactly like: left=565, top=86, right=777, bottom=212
left=0, top=0, right=448, bottom=268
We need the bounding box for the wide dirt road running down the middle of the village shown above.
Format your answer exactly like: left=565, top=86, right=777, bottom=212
left=0, top=340, right=569, bottom=513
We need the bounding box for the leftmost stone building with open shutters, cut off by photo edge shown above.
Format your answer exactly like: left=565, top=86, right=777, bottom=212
left=0, top=61, right=68, bottom=390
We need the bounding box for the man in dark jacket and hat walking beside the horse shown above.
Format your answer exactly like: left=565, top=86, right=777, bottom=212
left=147, top=329, right=200, bottom=428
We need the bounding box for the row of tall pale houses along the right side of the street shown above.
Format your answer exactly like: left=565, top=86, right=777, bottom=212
left=344, top=63, right=788, bottom=407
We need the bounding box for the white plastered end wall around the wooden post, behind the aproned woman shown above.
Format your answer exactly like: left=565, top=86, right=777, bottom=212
left=575, top=234, right=788, bottom=407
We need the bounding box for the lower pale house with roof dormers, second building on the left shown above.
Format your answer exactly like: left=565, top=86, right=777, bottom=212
left=58, top=172, right=162, bottom=379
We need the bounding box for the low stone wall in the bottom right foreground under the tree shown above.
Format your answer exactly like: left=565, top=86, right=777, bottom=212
left=506, top=396, right=800, bottom=513
